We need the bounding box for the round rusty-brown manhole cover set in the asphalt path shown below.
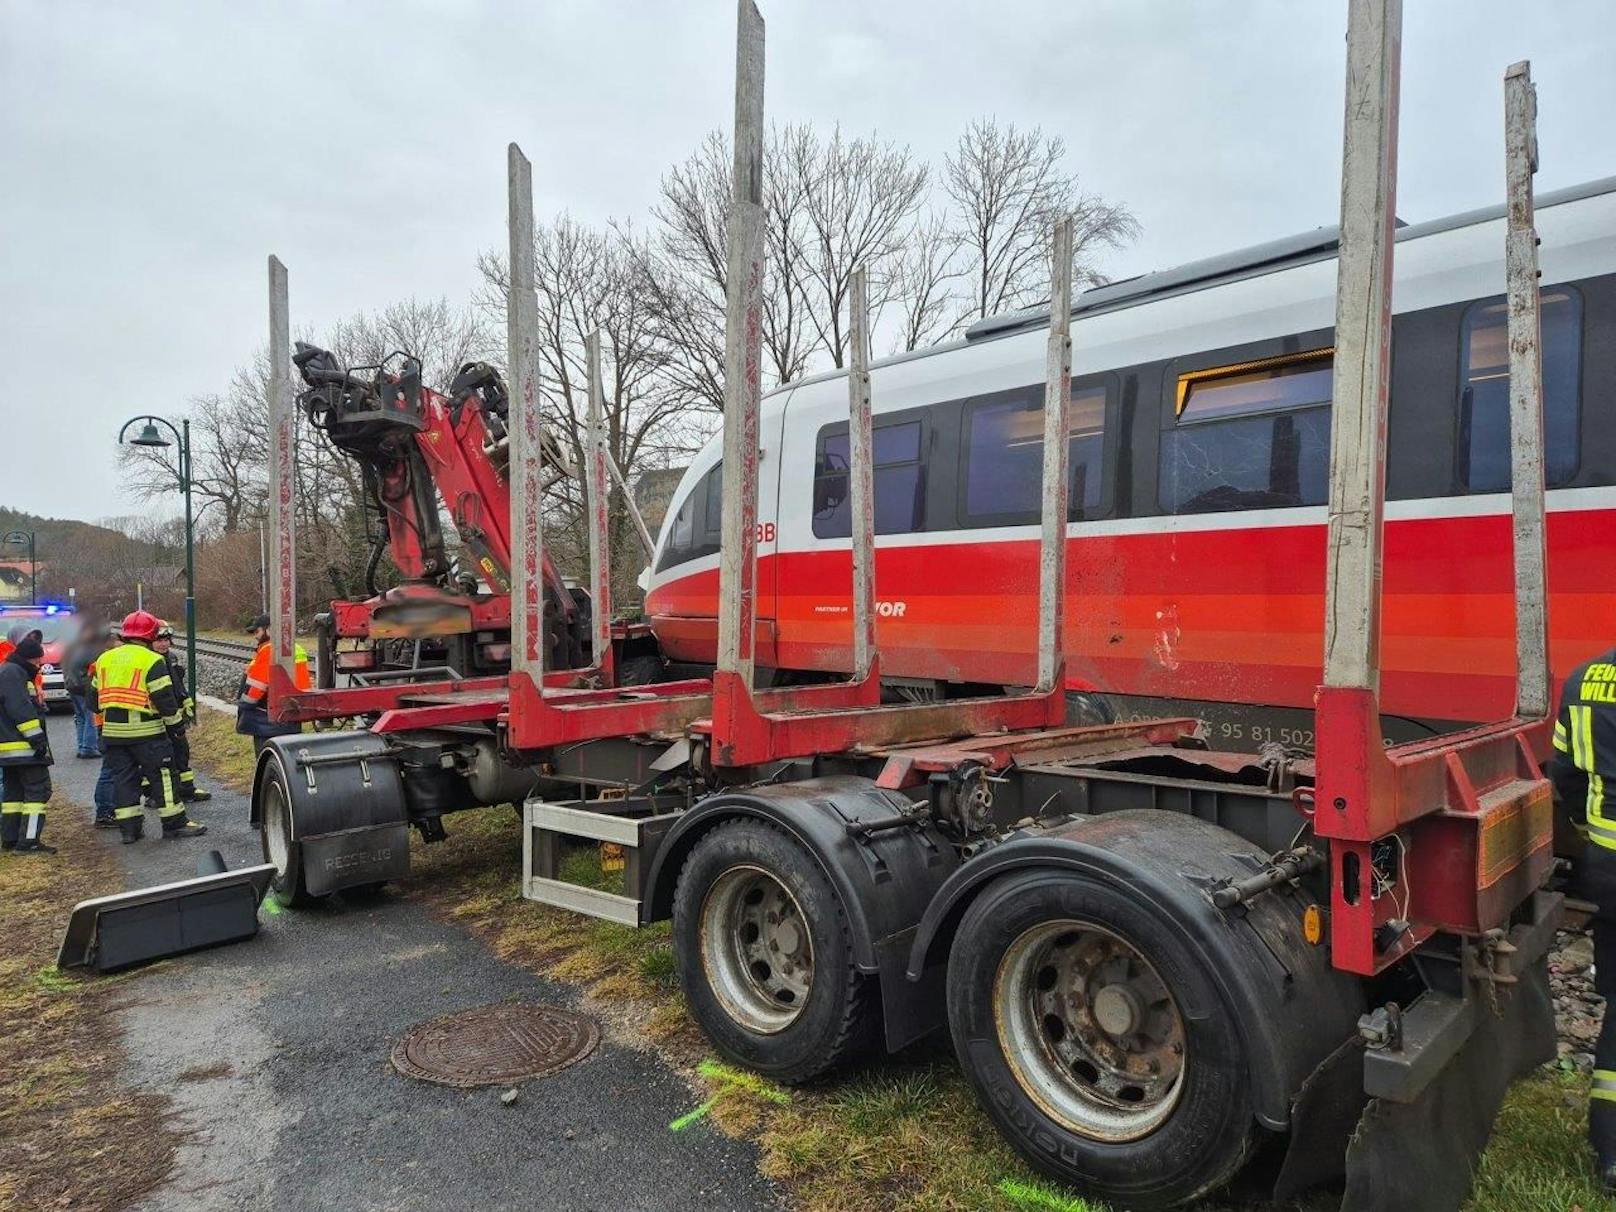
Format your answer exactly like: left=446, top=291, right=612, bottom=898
left=393, top=1004, right=601, bottom=1086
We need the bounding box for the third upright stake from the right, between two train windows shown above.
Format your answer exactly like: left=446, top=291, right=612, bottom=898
left=1036, top=215, right=1071, bottom=695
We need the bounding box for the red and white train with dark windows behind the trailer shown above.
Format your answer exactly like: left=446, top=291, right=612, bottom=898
left=646, top=178, right=1616, bottom=748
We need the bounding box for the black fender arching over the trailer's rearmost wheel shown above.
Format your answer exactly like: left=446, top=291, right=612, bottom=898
left=908, top=808, right=1364, bottom=1131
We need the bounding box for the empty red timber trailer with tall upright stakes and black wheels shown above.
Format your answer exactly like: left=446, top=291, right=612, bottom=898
left=254, top=0, right=1561, bottom=1209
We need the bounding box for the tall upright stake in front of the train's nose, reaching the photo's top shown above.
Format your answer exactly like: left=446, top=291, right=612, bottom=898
left=718, top=0, right=763, bottom=695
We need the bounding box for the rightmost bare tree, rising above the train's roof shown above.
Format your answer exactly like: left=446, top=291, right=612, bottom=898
left=944, top=118, right=1139, bottom=328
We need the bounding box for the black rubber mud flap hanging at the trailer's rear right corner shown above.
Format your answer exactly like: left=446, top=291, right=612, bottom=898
left=1341, top=958, right=1555, bottom=1212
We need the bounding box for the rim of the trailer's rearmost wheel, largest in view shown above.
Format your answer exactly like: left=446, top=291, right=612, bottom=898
left=994, top=920, right=1186, bottom=1141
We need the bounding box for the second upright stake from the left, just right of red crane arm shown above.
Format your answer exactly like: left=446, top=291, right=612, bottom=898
left=506, top=144, right=548, bottom=692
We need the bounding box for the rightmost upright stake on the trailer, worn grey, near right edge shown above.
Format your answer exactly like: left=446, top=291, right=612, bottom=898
left=1504, top=60, right=1550, bottom=719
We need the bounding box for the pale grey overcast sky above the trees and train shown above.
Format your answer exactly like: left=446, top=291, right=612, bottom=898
left=0, top=0, right=1616, bottom=519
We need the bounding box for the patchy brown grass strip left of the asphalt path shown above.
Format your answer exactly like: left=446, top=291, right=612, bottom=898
left=0, top=797, right=179, bottom=1212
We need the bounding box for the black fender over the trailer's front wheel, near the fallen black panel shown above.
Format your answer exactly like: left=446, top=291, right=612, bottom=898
left=250, top=732, right=409, bottom=897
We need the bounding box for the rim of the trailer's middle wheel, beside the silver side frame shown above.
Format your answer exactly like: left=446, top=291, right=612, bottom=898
left=701, top=865, right=813, bottom=1034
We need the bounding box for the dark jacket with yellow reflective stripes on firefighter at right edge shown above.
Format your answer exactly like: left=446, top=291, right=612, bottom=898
left=1548, top=648, right=1616, bottom=850
